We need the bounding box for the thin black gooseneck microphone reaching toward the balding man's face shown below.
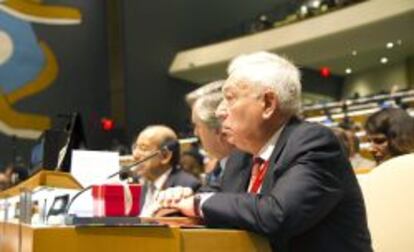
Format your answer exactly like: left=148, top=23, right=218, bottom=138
left=65, top=140, right=180, bottom=216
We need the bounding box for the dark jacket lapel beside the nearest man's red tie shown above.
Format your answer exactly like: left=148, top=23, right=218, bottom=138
left=260, top=117, right=300, bottom=193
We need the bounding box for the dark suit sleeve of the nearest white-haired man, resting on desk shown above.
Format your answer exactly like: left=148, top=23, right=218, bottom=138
left=202, top=127, right=349, bottom=236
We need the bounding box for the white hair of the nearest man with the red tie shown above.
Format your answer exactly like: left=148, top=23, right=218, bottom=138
left=227, top=52, right=302, bottom=114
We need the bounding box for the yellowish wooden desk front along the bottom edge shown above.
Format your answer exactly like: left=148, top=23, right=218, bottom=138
left=0, top=223, right=271, bottom=252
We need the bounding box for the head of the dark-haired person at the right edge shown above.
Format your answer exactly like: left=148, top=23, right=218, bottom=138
left=365, top=108, right=414, bottom=164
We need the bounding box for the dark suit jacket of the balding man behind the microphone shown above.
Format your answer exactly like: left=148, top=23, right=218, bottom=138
left=140, top=166, right=201, bottom=207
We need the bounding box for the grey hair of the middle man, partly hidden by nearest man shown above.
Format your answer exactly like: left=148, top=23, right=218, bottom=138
left=193, top=92, right=223, bottom=129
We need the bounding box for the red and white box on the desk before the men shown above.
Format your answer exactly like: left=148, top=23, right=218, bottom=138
left=92, top=184, right=142, bottom=217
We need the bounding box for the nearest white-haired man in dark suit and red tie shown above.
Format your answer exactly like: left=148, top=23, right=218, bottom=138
left=159, top=52, right=372, bottom=252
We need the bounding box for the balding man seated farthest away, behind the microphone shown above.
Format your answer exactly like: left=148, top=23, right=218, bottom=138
left=132, top=125, right=200, bottom=217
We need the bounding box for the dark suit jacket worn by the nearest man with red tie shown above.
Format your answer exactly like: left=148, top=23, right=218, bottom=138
left=202, top=119, right=372, bottom=252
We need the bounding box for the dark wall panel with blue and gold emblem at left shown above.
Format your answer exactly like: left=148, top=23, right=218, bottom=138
left=0, top=0, right=109, bottom=169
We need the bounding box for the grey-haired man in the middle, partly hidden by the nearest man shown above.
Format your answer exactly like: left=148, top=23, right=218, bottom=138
left=162, top=81, right=250, bottom=197
